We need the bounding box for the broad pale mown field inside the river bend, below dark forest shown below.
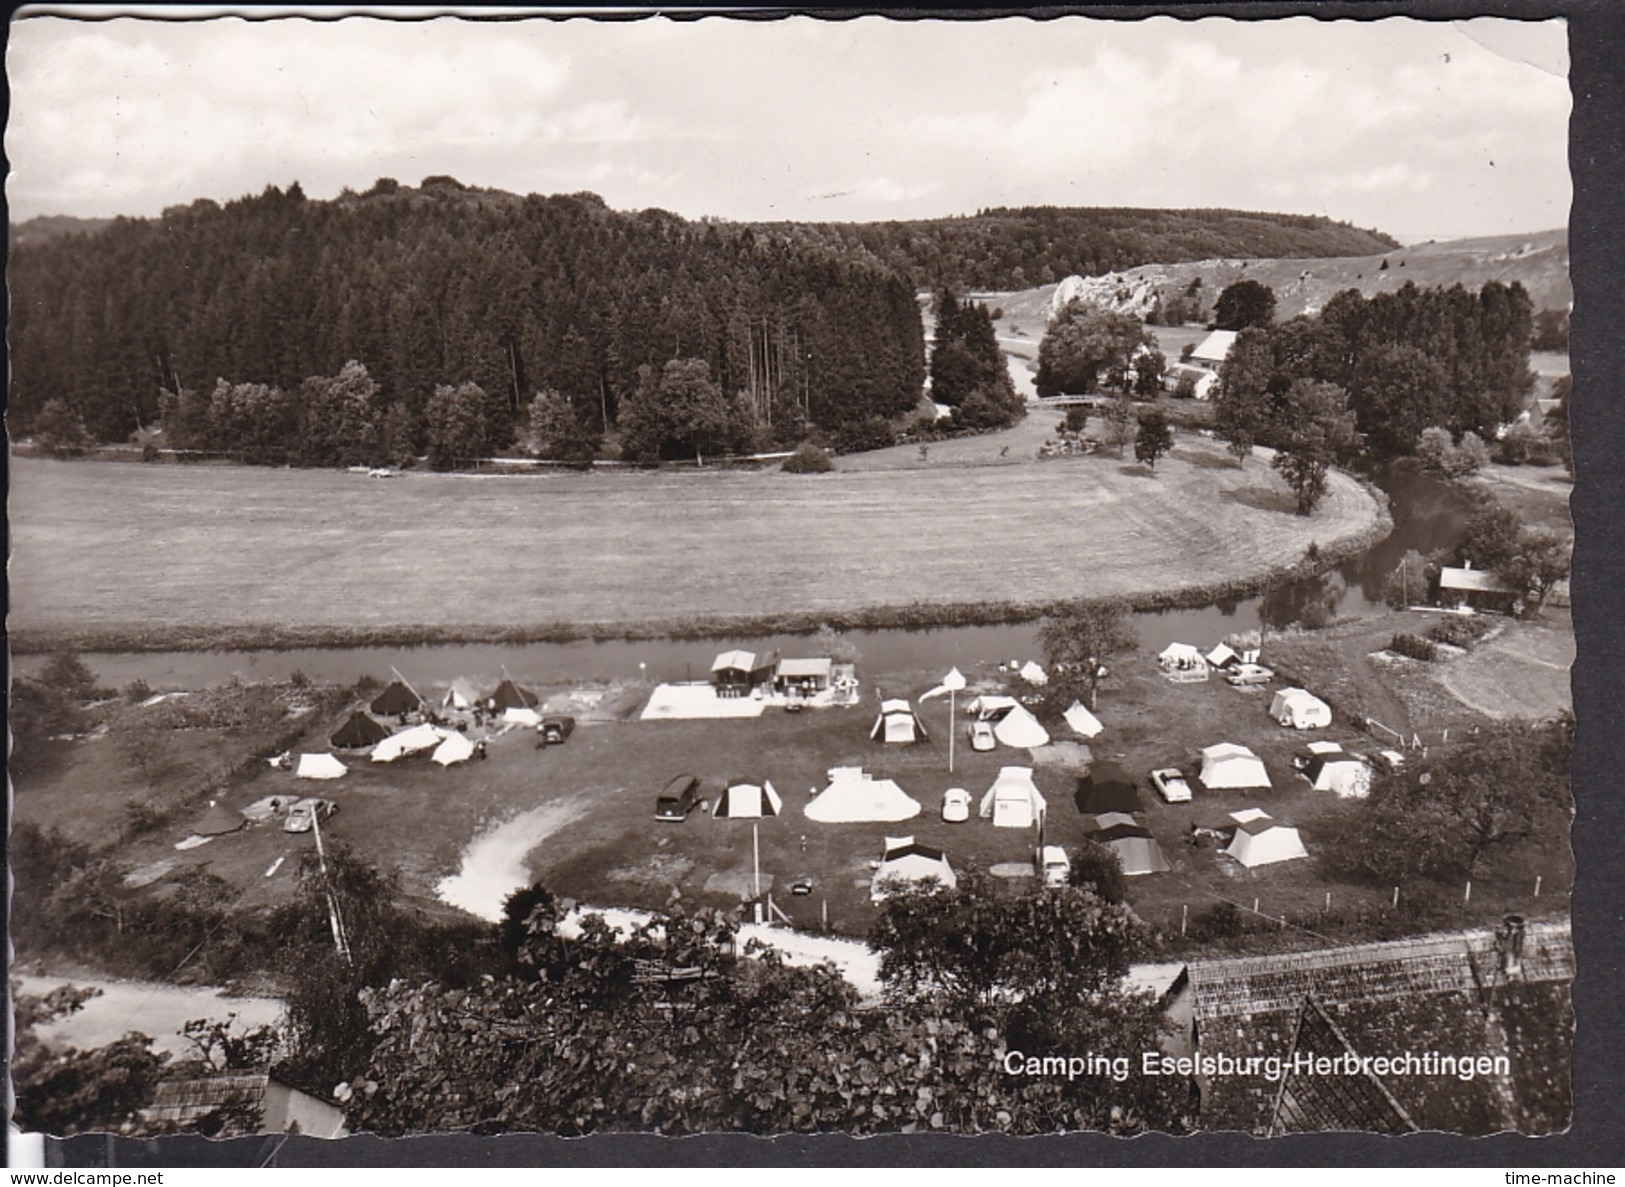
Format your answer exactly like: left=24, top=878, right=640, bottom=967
left=10, top=435, right=1380, bottom=649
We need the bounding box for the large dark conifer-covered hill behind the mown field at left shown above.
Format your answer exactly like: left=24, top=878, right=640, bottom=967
left=10, top=177, right=925, bottom=445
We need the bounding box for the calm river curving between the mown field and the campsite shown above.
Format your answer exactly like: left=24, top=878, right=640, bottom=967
left=16, top=470, right=1472, bottom=689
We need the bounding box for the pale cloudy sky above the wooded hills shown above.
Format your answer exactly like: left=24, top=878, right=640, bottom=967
left=5, top=7, right=1571, bottom=241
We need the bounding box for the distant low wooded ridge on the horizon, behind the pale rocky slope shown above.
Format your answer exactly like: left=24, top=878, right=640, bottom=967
left=757, top=207, right=1399, bottom=291
